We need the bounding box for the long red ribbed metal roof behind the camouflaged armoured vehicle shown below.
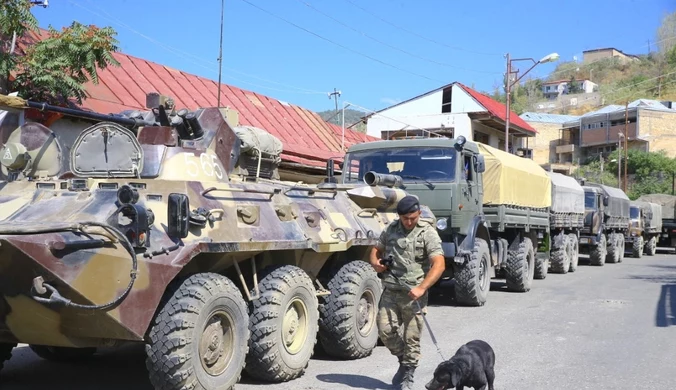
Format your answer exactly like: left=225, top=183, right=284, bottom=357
left=19, top=30, right=379, bottom=167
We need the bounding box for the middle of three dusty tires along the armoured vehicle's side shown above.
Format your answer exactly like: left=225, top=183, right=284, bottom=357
left=246, top=265, right=319, bottom=382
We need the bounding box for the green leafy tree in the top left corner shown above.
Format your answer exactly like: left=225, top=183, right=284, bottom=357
left=0, top=0, right=119, bottom=104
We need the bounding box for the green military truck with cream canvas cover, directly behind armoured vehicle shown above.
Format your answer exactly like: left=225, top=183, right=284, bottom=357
left=341, top=136, right=552, bottom=306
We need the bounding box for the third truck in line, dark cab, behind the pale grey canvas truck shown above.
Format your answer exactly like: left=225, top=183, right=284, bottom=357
left=580, top=180, right=629, bottom=266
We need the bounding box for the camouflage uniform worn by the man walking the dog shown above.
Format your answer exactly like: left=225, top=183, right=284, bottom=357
left=377, top=220, right=444, bottom=367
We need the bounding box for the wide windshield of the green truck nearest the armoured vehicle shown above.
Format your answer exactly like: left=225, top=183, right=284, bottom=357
left=343, top=147, right=457, bottom=183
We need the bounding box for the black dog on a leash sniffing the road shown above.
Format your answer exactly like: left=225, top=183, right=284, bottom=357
left=425, top=340, right=495, bottom=390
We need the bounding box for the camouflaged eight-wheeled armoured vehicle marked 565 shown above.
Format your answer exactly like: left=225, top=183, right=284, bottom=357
left=0, top=94, right=435, bottom=390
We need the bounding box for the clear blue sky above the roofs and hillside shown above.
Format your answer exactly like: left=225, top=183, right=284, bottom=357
left=27, top=0, right=676, bottom=111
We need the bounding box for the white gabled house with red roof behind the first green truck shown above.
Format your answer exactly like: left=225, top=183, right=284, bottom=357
left=365, top=82, right=536, bottom=157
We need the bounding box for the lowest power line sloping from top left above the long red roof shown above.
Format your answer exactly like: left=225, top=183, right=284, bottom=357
left=68, top=0, right=326, bottom=95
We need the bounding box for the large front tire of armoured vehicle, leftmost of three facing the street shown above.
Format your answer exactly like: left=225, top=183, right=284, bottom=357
left=146, top=273, right=249, bottom=390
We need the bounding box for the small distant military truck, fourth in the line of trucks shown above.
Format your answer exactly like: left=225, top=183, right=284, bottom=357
left=624, top=201, right=662, bottom=258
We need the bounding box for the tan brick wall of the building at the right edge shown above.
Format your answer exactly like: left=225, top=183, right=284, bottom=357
left=638, top=109, right=676, bottom=157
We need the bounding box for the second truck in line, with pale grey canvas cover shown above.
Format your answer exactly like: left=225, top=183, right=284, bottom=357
left=547, top=172, right=585, bottom=274
